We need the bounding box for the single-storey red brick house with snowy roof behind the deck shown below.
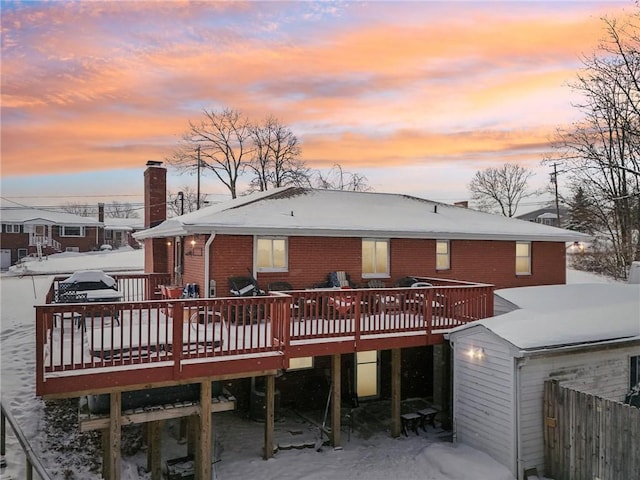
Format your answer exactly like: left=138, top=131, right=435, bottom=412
left=134, top=165, right=589, bottom=296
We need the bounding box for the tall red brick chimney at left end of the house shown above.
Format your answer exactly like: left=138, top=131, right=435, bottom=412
left=144, top=160, right=170, bottom=273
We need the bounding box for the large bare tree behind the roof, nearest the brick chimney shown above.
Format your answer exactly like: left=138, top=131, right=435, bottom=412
left=167, top=108, right=252, bottom=198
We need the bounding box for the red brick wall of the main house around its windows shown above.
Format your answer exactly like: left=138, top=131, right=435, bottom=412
left=202, top=235, right=566, bottom=296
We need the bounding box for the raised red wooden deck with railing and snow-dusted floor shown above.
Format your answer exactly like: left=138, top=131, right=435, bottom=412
left=36, top=276, right=493, bottom=397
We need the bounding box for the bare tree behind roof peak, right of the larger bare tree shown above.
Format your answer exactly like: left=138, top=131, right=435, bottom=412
left=247, top=116, right=310, bottom=191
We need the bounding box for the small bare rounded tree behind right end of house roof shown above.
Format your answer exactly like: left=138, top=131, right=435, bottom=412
left=469, top=163, right=536, bottom=217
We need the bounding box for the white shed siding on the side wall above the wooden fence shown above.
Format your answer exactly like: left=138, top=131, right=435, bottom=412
left=519, top=346, right=640, bottom=473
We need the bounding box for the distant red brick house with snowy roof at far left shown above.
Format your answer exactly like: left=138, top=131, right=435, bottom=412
left=0, top=207, right=103, bottom=269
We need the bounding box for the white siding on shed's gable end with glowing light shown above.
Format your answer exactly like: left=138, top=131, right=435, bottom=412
left=453, top=327, right=515, bottom=475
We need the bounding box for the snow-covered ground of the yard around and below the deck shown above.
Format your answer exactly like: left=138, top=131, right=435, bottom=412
left=0, top=249, right=611, bottom=480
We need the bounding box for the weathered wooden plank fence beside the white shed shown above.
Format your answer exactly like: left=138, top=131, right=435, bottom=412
left=544, top=380, right=640, bottom=480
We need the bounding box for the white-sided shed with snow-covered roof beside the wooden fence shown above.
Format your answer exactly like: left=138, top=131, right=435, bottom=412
left=449, top=284, right=640, bottom=479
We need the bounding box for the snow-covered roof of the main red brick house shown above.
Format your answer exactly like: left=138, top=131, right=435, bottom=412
left=134, top=187, right=590, bottom=242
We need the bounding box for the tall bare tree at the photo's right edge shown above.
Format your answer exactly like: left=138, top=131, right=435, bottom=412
left=546, top=9, right=640, bottom=278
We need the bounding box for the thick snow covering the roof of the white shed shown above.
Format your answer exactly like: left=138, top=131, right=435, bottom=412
left=451, top=283, right=640, bottom=350
